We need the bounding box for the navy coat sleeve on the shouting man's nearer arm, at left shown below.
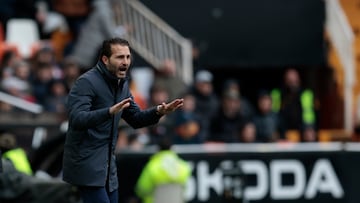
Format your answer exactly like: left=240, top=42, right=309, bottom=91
left=67, top=78, right=111, bottom=129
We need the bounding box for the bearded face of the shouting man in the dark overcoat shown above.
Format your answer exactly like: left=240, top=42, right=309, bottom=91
left=102, top=44, right=131, bottom=79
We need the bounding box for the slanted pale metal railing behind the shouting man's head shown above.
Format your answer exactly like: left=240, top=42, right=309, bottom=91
left=114, top=0, right=193, bottom=84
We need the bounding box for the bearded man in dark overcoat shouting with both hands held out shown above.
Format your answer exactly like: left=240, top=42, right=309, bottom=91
left=63, top=38, right=183, bottom=203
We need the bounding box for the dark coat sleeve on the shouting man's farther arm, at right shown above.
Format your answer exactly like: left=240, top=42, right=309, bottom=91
left=122, top=96, right=161, bottom=128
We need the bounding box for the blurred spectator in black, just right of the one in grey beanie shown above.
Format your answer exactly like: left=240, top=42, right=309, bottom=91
left=208, top=89, right=247, bottom=143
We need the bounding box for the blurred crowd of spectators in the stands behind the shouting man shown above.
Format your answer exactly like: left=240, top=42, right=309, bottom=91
left=0, top=0, right=318, bottom=154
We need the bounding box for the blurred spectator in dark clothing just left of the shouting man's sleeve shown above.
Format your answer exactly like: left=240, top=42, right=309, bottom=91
left=44, top=80, right=68, bottom=114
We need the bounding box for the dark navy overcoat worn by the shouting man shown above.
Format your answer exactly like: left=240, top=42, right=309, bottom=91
left=63, top=61, right=160, bottom=191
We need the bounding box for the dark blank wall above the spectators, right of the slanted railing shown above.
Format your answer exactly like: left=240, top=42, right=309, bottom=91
left=142, top=0, right=325, bottom=67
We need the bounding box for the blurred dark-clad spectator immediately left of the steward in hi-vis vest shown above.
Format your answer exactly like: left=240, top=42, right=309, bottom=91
left=254, top=90, right=280, bottom=142
